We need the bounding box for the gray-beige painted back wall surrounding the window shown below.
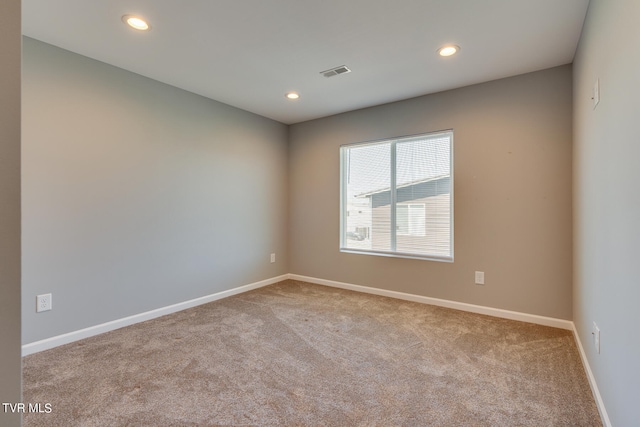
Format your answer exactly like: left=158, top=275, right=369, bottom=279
left=289, top=65, right=572, bottom=319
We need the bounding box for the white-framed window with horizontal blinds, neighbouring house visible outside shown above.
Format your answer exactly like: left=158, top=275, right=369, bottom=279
left=340, top=131, right=453, bottom=261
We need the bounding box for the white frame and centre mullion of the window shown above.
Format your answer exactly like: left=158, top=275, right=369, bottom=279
left=340, top=129, right=454, bottom=262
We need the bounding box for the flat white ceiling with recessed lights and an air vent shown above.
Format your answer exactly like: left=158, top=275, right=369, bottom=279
left=22, top=0, right=589, bottom=124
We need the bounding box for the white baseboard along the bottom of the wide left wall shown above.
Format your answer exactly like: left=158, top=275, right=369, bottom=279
left=22, top=274, right=288, bottom=356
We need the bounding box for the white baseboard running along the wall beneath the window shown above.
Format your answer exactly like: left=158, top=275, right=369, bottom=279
left=289, top=274, right=573, bottom=331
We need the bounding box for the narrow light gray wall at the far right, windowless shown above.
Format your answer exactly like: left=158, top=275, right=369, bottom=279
left=574, top=0, right=640, bottom=426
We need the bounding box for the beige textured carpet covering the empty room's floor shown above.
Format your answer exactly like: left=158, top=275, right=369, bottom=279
left=23, top=281, right=602, bottom=427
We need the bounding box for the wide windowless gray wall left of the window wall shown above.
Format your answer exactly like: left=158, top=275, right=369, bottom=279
left=22, top=38, right=288, bottom=344
